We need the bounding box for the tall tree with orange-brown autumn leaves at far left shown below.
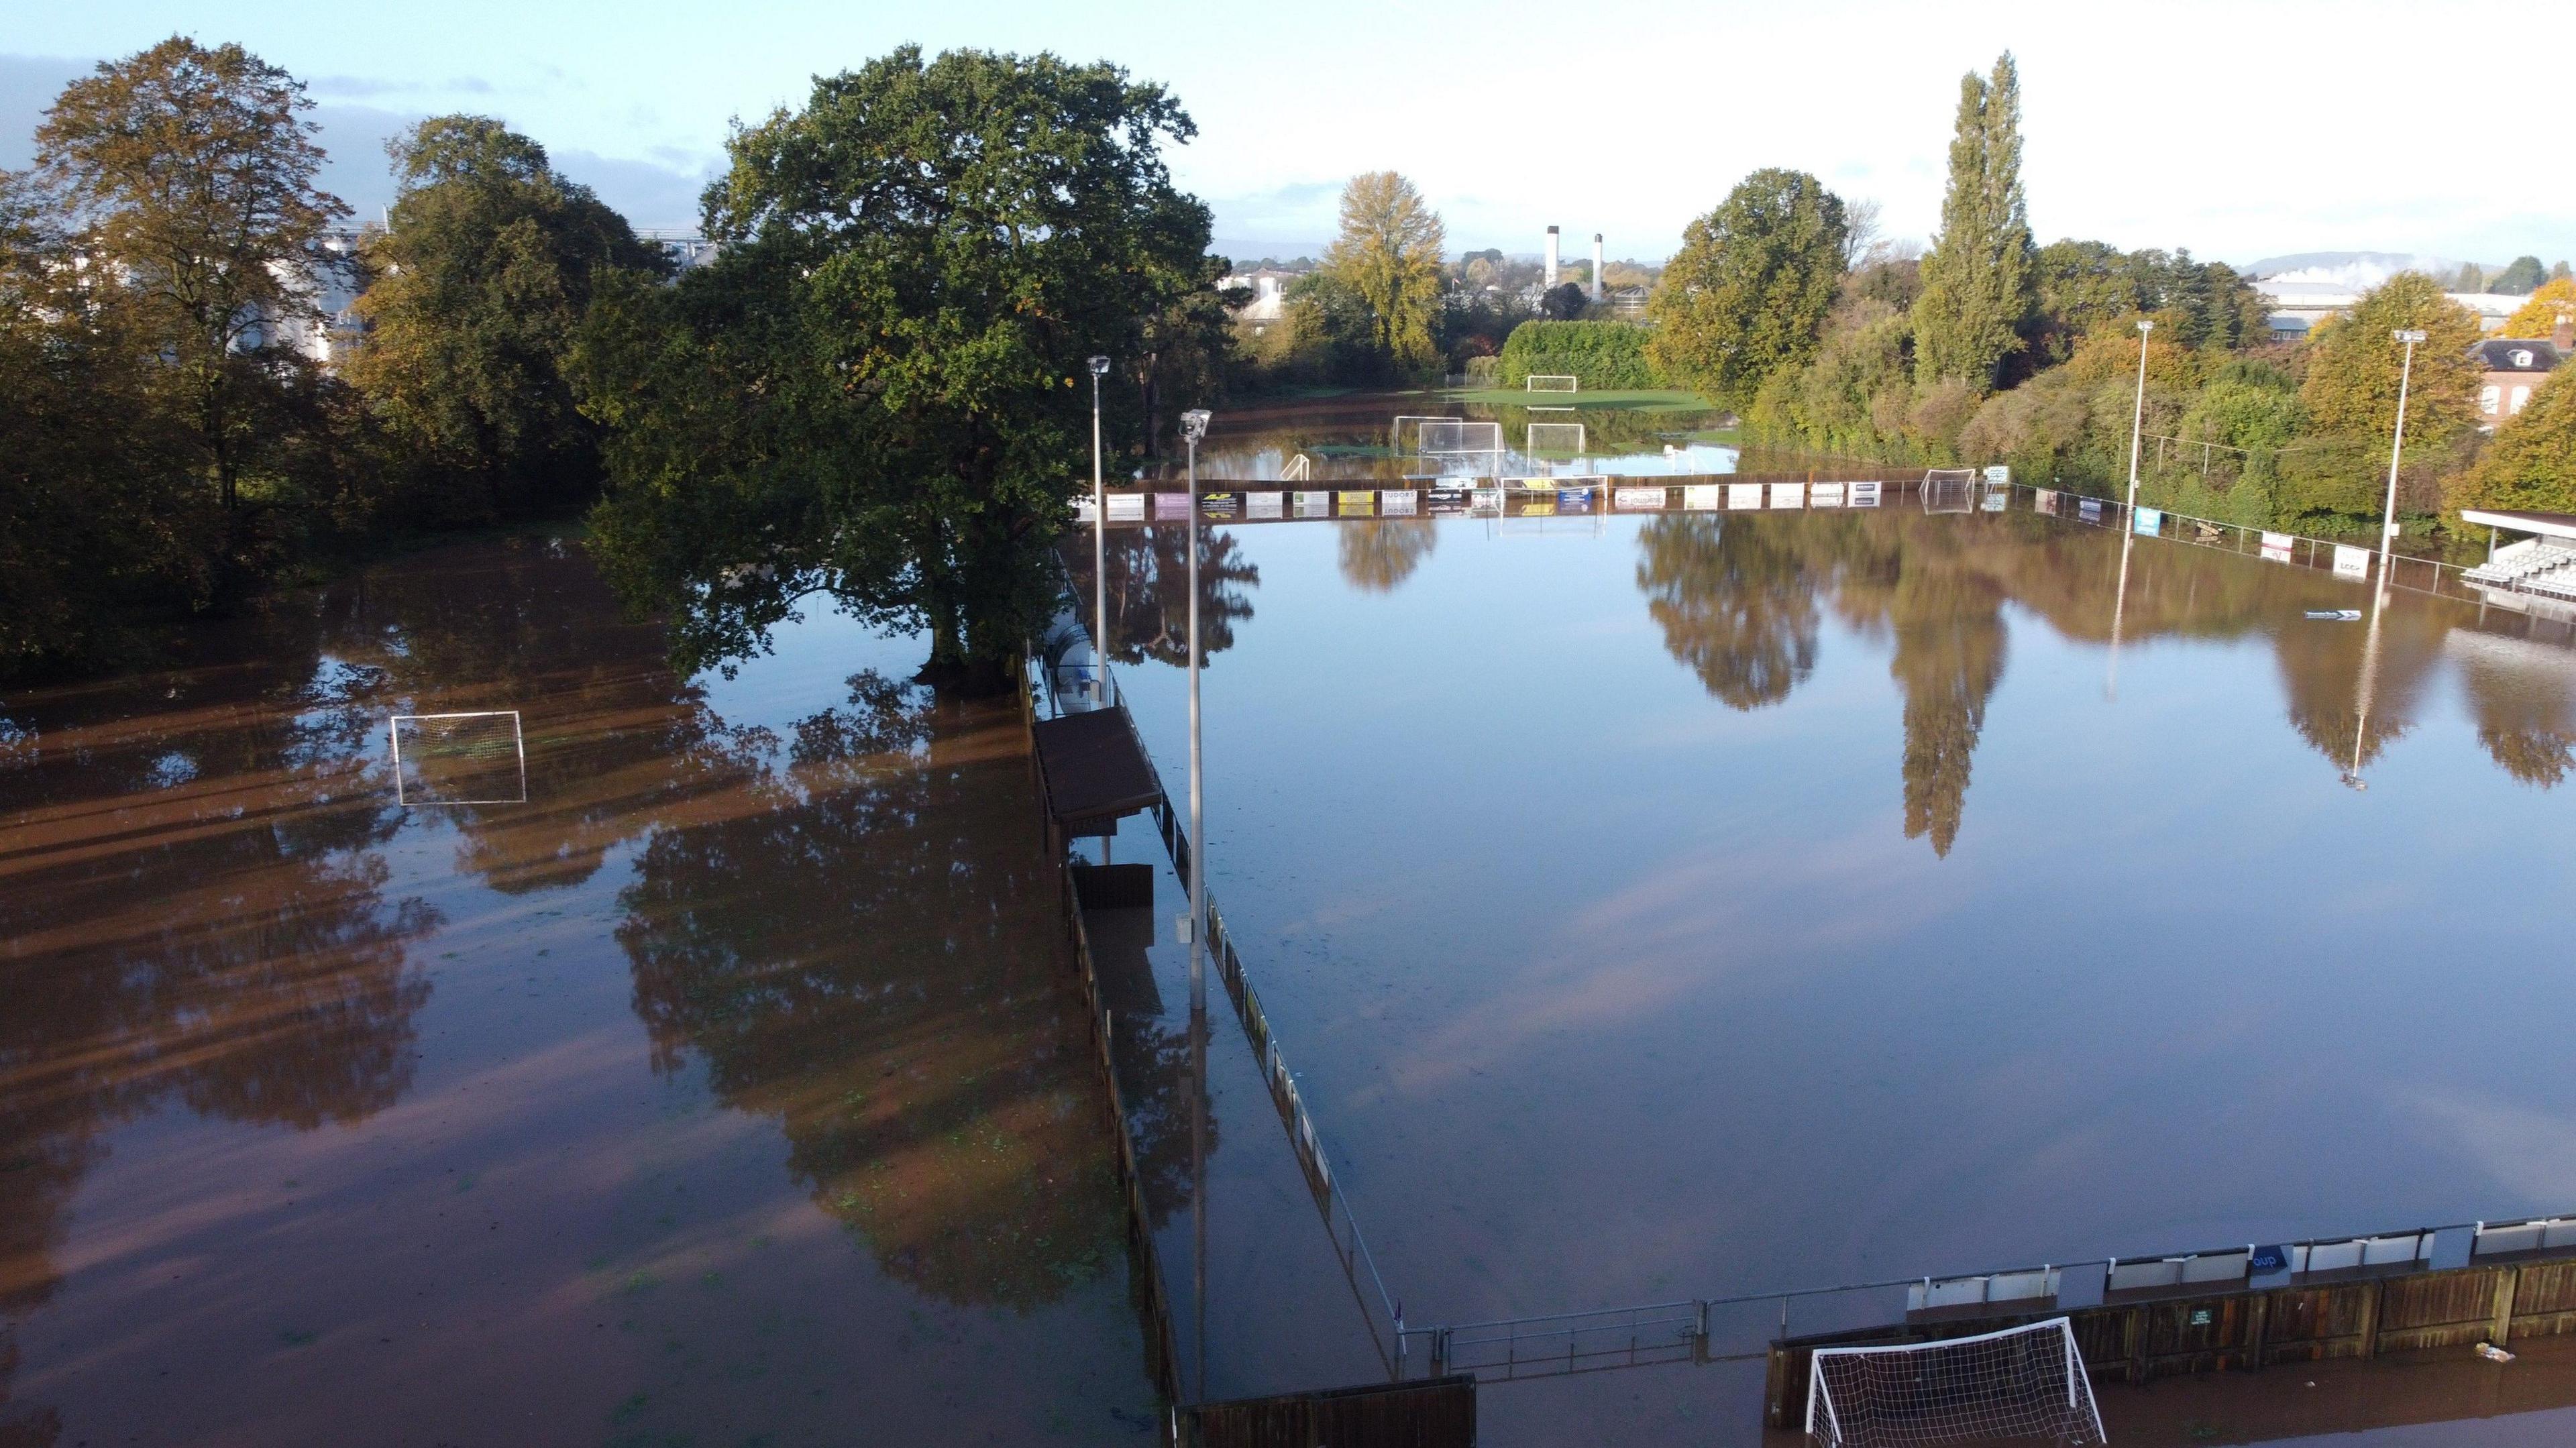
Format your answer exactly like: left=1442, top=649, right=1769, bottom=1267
left=36, top=36, right=347, bottom=510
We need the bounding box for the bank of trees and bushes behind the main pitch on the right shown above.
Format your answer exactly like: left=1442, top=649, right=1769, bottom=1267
left=1649, top=54, right=2576, bottom=533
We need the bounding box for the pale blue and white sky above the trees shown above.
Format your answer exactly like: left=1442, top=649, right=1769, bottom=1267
left=0, top=0, right=2576, bottom=263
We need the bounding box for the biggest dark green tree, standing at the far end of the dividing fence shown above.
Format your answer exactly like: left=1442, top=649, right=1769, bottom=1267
left=574, top=46, right=1208, bottom=688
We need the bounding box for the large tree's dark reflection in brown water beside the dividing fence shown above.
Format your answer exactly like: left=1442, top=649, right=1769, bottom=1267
left=619, top=675, right=1120, bottom=1306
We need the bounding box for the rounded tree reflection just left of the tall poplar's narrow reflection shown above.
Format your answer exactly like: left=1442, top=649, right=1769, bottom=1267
left=1635, top=515, right=1819, bottom=708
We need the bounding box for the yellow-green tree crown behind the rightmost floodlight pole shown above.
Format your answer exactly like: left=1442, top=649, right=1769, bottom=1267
left=2300, top=270, right=2481, bottom=446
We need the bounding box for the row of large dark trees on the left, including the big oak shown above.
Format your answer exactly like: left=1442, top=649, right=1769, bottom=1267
left=0, top=39, right=1226, bottom=680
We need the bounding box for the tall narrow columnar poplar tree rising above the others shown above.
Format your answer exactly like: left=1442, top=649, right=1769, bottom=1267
left=1914, top=52, right=2035, bottom=394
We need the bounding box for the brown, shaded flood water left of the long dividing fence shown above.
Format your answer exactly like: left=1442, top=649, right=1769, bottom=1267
left=0, top=541, right=1159, bottom=1448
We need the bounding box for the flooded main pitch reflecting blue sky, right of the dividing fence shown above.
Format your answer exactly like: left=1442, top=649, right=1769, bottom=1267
left=1092, top=495, right=2576, bottom=1427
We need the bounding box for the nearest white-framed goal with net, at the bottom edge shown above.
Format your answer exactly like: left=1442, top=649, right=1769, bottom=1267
left=1806, top=1317, right=2107, bottom=1448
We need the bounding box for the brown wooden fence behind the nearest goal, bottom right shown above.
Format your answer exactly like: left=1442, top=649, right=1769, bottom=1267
left=1764, top=1260, right=2576, bottom=1427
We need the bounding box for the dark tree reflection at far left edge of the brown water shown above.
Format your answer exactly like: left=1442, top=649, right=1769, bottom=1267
left=0, top=636, right=438, bottom=1350
